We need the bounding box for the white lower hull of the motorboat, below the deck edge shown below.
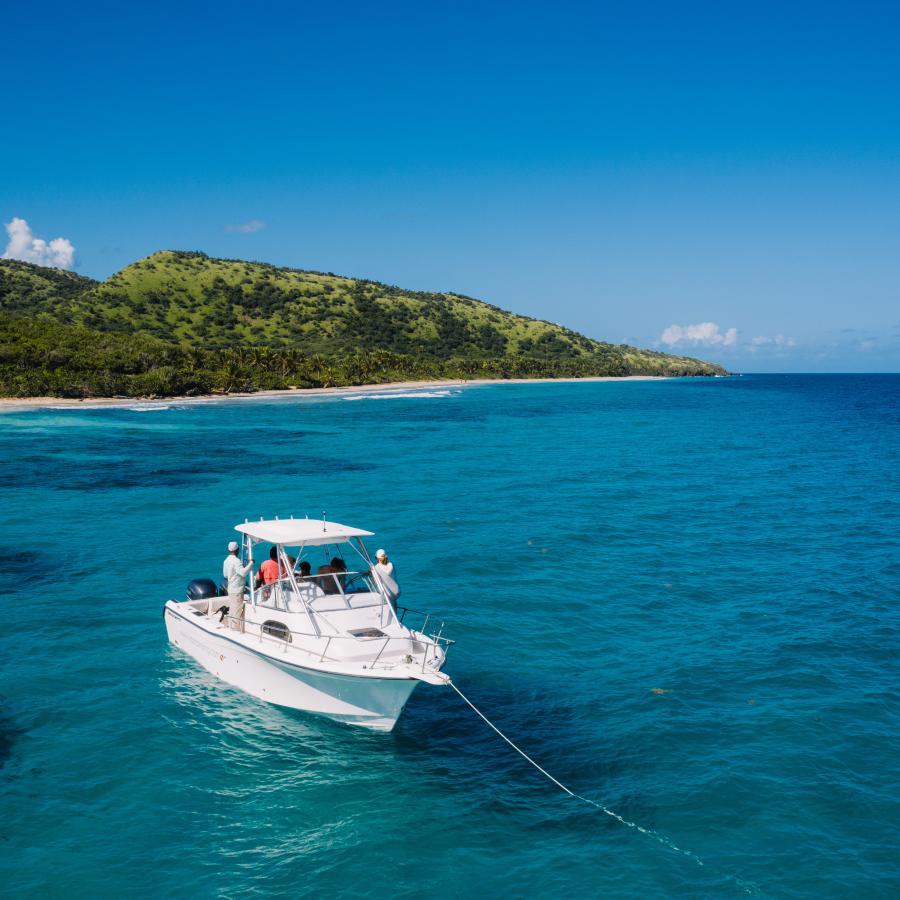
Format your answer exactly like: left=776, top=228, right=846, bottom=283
left=164, top=605, right=419, bottom=731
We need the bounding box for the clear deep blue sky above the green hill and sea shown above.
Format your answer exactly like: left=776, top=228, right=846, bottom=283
left=0, top=0, right=900, bottom=372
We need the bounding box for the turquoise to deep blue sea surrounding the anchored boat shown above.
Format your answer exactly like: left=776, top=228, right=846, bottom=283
left=0, top=376, right=900, bottom=898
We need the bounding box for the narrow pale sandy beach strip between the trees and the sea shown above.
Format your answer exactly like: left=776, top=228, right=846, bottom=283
left=0, top=375, right=677, bottom=412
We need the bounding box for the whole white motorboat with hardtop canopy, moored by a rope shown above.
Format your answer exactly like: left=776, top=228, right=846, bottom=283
left=163, top=518, right=453, bottom=731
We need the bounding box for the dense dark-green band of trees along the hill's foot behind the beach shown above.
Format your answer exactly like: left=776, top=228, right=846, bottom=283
left=0, top=314, right=717, bottom=397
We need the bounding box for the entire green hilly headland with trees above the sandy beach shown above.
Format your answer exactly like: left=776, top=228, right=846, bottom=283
left=0, top=251, right=724, bottom=395
